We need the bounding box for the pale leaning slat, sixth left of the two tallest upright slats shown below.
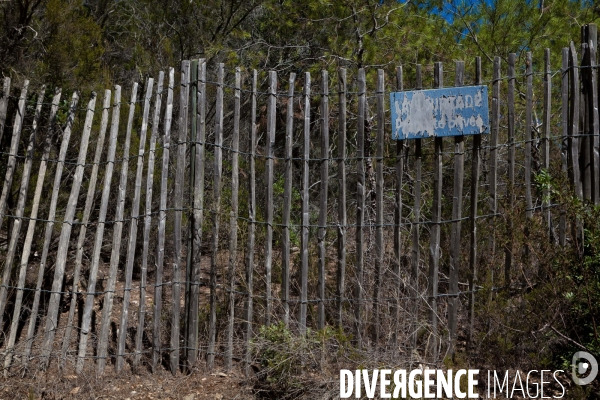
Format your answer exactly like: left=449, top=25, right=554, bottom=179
left=59, top=90, right=111, bottom=366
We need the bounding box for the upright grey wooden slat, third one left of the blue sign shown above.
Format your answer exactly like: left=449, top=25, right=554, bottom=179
left=337, top=68, right=347, bottom=327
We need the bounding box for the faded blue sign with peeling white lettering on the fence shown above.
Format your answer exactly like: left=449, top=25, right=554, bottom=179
left=390, top=86, right=490, bottom=140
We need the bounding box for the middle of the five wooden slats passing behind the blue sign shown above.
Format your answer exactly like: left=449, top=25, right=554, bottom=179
left=428, top=62, right=444, bottom=362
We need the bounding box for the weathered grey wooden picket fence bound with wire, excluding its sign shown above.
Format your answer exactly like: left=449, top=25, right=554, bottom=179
left=0, top=25, right=600, bottom=373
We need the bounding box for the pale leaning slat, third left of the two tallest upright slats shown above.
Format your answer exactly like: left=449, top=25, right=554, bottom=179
left=115, top=78, right=154, bottom=372
